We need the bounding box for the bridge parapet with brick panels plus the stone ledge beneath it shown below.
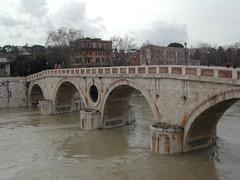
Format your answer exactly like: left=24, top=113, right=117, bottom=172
left=26, top=65, right=240, bottom=85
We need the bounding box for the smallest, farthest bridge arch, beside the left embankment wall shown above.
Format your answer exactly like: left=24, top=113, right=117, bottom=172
left=28, top=82, right=45, bottom=107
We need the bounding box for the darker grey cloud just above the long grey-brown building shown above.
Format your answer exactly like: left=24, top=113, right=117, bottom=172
left=136, top=21, right=188, bottom=45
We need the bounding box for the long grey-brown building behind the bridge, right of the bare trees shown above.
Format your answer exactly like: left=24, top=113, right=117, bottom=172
left=140, top=45, right=191, bottom=65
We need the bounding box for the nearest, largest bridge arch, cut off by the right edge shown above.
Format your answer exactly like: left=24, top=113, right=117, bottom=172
left=183, top=89, right=240, bottom=152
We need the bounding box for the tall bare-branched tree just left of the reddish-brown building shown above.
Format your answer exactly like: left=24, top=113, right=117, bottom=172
left=46, top=27, right=83, bottom=67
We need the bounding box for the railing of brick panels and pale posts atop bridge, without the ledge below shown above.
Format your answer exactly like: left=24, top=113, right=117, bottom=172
left=26, top=65, right=240, bottom=82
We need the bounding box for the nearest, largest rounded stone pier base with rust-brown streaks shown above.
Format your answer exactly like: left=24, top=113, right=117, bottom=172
left=150, top=123, right=183, bottom=154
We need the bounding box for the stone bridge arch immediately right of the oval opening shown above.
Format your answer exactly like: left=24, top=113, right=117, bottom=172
left=101, top=79, right=159, bottom=128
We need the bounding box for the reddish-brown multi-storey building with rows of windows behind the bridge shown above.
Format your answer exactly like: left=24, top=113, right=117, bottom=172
left=70, top=38, right=112, bottom=67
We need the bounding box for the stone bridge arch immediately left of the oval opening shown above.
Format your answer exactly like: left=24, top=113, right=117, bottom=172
left=53, top=79, right=86, bottom=113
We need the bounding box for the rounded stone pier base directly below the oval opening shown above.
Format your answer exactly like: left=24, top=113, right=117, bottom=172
left=80, top=109, right=101, bottom=130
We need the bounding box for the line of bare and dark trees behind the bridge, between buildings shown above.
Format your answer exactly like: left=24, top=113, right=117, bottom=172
left=0, top=27, right=240, bottom=76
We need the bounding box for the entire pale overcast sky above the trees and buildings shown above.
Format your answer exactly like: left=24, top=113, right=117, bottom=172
left=0, top=0, right=240, bottom=46
